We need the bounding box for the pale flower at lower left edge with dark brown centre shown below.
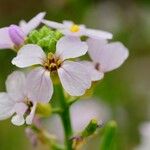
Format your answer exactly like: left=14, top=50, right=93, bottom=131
left=0, top=71, right=49, bottom=126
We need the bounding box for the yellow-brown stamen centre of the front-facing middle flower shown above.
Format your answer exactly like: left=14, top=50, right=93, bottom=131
left=43, top=53, right=62, bottom=72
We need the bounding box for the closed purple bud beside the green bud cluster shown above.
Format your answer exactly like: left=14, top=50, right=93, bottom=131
left=8, top=25, right=25, bottom=46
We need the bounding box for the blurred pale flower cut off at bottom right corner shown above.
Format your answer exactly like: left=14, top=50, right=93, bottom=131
left=135, top=122, right=150, bottom=150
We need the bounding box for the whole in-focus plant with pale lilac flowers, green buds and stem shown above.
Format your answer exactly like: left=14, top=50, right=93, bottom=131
left=0, top=13, right=128, bottom=150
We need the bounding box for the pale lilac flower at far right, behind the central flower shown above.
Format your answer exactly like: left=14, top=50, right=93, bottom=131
left=82, top=38, right=129, bottom=81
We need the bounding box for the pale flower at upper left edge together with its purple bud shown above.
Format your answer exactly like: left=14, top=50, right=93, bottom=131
left=0, top=12, right=45, bottom=49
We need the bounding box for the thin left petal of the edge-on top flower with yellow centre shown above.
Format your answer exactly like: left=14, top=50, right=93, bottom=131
left=42, top=19, right=65, bottom=29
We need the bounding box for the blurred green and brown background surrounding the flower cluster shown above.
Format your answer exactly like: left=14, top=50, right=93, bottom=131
left=0, top=0, right=150, bottom=150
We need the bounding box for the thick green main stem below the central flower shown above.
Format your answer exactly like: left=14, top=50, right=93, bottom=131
left=54, top=85, right=73, bottom=150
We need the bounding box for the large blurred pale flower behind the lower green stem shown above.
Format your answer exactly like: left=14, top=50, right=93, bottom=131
left=43, top=99, right=111, bottom=141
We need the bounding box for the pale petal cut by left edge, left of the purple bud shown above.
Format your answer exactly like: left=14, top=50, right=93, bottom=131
left=0, top=27, right=14, bottom=49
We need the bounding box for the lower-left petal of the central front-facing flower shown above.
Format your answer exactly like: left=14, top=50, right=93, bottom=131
left=27, top=67, right=53, bottom=103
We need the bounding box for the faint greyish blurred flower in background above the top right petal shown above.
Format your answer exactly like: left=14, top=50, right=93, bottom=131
left=84, top=1, right=123, bottom=34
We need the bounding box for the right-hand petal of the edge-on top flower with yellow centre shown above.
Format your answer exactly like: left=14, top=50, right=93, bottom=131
left=85, top=29, right=113, bottom=39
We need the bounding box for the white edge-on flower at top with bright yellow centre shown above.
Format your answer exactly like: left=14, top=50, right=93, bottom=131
left=42, top=20, right=112, bottom=39
